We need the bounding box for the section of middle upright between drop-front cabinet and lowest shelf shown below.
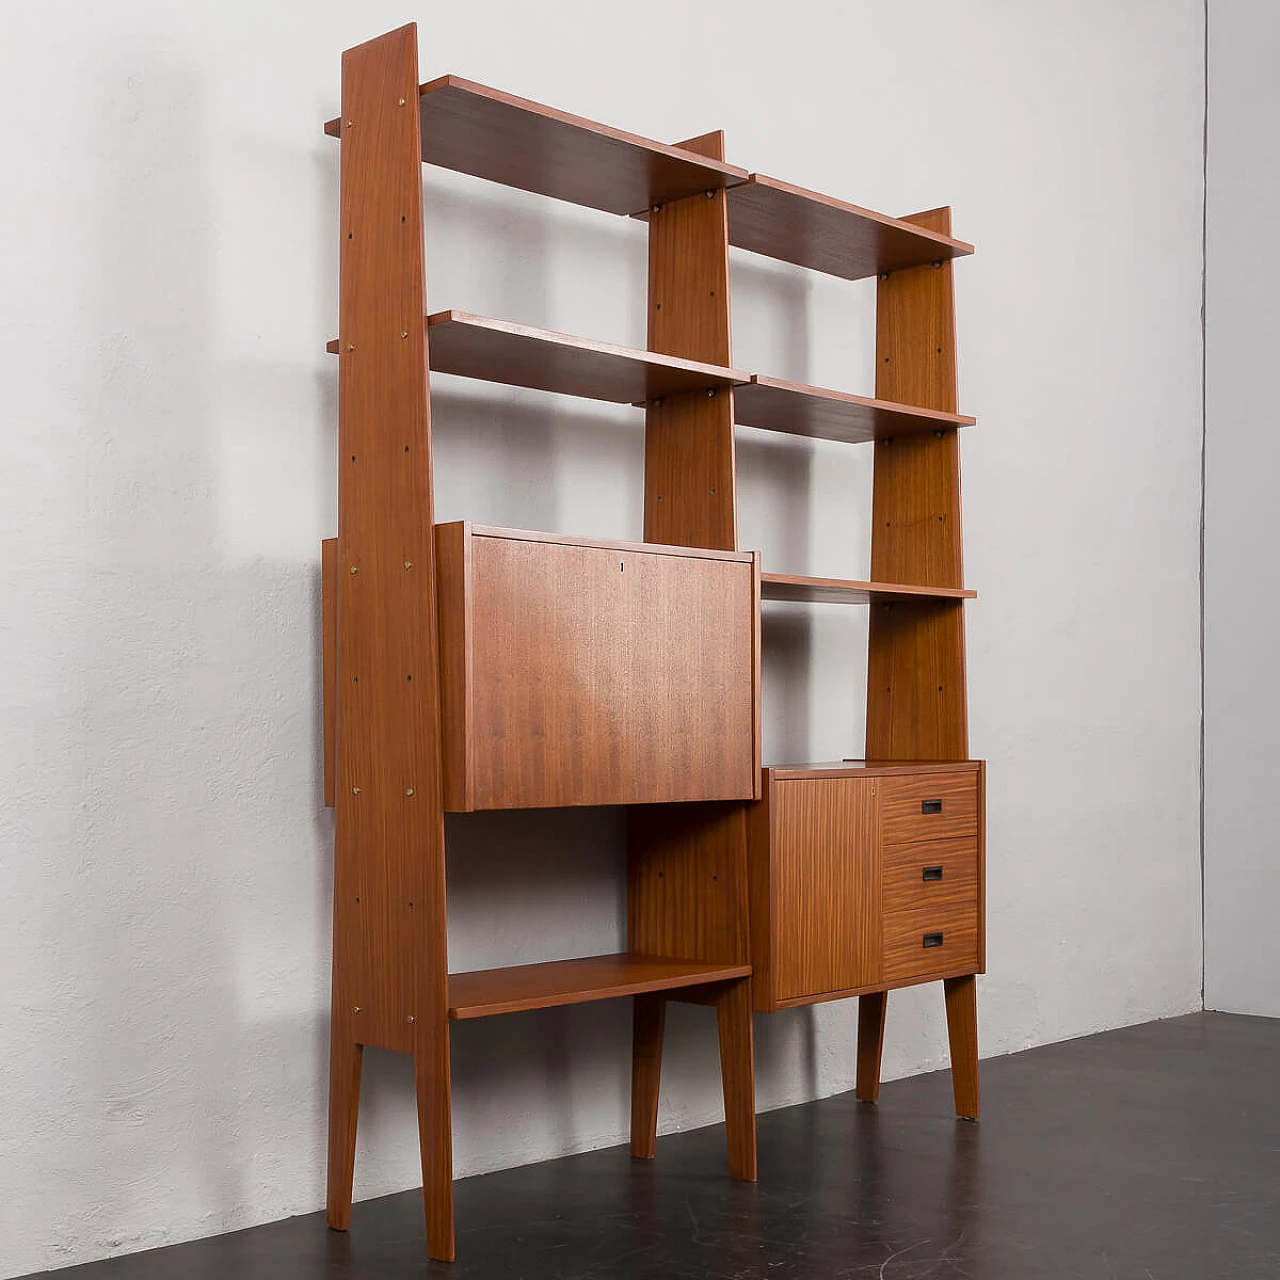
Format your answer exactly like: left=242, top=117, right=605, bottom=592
left=627, top=804, right=750, bottom=964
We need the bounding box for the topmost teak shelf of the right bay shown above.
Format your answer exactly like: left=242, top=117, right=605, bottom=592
left=728, top=173, right=973, bottom=280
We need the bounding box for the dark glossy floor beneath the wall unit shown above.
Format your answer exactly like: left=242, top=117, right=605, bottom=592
left=27, top=1014, right=1280, bottom=1280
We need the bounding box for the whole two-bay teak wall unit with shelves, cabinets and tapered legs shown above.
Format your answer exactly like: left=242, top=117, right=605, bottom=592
left=323, top=26, right=984, bottom=1260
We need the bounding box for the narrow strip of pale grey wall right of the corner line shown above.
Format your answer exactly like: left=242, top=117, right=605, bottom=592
left=1204, top=0, right=1280, bottom=1018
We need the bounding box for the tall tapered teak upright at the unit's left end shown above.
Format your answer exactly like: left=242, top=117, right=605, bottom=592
left=329, top=24, right=453, bottom=1260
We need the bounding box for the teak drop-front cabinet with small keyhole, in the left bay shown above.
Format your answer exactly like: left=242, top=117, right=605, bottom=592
left=438, top=530, right=759, bottom=809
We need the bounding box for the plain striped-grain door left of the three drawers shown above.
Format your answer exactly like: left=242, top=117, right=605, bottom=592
left=772, top=778, right=881, bottom=1000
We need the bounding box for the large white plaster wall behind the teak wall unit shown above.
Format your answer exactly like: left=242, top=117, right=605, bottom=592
left=0, top=0, right=1202, bottom=1276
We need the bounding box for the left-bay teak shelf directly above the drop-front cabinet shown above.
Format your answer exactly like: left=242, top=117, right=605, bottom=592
left=426, top=311, right=751, bottom=401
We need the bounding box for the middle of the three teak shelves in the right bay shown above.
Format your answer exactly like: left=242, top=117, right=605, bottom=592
left=733, top=375, right=974, bottom=444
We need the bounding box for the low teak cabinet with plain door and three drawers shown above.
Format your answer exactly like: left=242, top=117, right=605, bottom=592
left=748, top=762, right=984, bottom=1011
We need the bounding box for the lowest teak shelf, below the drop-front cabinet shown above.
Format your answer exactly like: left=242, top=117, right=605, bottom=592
left=449, top=952, right=751, bottom=1019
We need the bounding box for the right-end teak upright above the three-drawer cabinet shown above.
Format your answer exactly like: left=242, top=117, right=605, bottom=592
left=865, top=209, right=969, bottom=760
